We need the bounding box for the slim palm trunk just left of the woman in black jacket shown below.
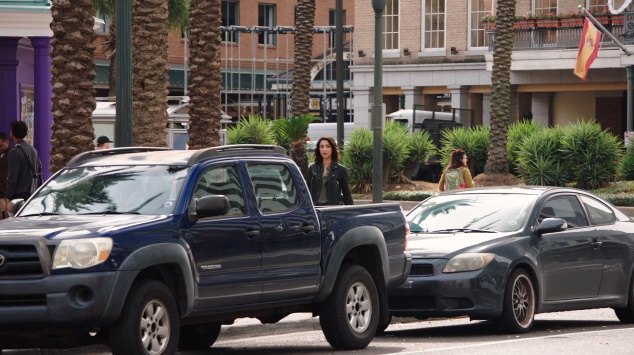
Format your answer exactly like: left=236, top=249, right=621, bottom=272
left=291, top=0, right=315, bottom=117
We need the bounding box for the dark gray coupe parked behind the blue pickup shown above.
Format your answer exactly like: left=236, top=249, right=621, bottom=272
left=389, top=187, right=634, bottom=333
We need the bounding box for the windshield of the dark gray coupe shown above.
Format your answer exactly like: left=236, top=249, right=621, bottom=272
left=407, top=194, right=537, bottom=233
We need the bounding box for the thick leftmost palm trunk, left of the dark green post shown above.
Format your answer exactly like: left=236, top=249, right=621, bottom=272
left=50, top=0, right=95, bottom=173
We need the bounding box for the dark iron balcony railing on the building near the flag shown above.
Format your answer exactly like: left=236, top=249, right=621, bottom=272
left=486, top=24, right=623, bottom=52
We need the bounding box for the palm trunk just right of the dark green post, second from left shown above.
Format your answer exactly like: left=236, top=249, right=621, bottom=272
left=132, top=0, right=169, bottom=147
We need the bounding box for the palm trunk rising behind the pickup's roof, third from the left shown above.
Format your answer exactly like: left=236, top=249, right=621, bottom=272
left=188, top=0, right=222, bottom=149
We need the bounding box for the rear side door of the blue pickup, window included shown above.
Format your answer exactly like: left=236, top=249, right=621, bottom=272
left=247, top=162, right=321, bottom=302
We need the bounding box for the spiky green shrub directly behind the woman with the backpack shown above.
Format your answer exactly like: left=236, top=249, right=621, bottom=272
left=440, top=126, right=491, bottom=176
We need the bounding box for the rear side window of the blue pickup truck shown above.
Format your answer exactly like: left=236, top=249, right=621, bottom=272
left=247, top=164, right=299, bottom=214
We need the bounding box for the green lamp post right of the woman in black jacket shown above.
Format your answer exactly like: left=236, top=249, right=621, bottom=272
left=372, top=0, right=385, bottom=203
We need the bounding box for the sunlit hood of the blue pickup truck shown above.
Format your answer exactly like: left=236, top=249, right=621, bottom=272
left=0, top=215, right=168, bottom=241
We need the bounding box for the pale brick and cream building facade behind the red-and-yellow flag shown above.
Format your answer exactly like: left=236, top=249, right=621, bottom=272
left=352, top=0, right=634, bottom=137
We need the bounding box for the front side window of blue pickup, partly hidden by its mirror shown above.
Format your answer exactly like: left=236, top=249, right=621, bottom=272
left=194, top=165, right=246, bottom=216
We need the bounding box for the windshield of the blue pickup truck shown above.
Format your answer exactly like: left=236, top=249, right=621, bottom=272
left=20, top=165, right=188, bottom=216
